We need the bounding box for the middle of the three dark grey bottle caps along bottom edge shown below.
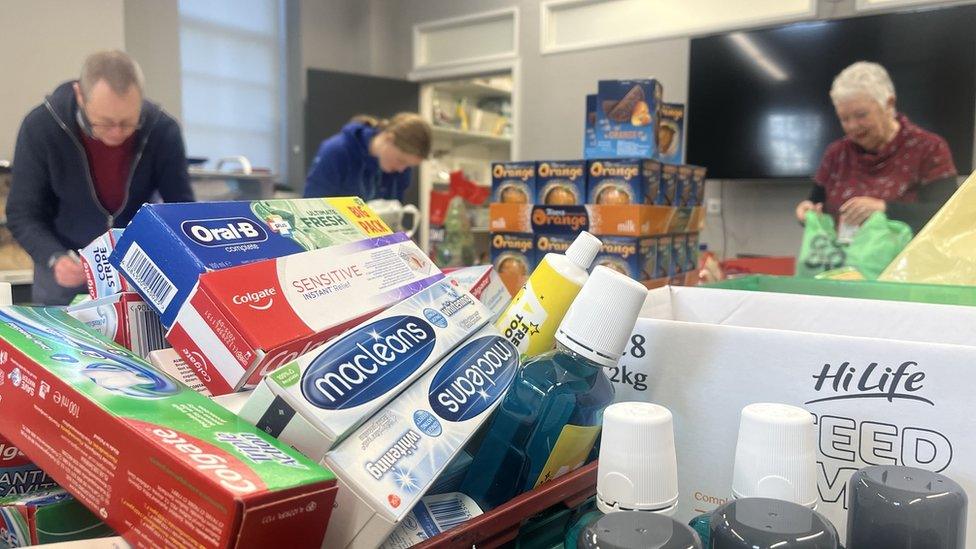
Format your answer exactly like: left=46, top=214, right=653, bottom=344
left=709, top=498, right=837, bottom=549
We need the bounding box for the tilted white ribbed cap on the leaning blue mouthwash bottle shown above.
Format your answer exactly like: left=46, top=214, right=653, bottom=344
left=556, top=266, right=647, bottom=367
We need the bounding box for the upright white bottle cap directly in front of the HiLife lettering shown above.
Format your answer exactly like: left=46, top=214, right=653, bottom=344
left=732, top=403, right=818, bottom=509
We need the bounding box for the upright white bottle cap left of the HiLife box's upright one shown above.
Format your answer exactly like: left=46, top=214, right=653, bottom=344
left=596, top=402, right=678, bottom=514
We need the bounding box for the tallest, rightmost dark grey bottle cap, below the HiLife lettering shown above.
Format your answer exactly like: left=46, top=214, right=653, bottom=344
left=847, top=465, right=967, bottom=549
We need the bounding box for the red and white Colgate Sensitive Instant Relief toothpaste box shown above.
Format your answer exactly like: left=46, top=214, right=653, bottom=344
left=166, top=233, right=444, bottom=395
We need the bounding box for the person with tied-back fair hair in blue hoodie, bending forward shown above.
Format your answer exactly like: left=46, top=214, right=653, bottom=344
left=305, top=112, right=431, bottom=202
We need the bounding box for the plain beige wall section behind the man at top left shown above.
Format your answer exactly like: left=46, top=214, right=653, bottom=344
left=0, top=0, right=125, bottom=159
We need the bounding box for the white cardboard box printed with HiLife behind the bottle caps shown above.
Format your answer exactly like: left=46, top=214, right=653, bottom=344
left=607, top=287, right=976, bottom=543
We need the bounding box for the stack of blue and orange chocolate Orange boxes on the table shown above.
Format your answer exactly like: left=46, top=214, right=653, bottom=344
left=490, top=80, right=706, bottom=291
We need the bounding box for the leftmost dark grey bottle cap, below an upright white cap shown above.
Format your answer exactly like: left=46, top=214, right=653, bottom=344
left=576, top=511, right=702, bottom=549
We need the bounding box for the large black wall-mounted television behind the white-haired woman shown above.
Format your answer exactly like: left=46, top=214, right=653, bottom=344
left=687, top=5, right=976, bottom=179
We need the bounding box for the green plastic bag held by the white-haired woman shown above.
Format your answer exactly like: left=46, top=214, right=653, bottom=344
left=796, top=211, right=912, bottom=280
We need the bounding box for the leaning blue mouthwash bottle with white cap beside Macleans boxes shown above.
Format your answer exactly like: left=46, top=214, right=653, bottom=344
left=461, top=267, right=647, bottom=511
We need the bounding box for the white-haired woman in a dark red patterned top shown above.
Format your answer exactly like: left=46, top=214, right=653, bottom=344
left=796, top=61, right=956, bottom=232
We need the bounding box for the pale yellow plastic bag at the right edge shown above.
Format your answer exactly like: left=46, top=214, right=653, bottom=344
left=878, top=173, right=976, bottom=286
